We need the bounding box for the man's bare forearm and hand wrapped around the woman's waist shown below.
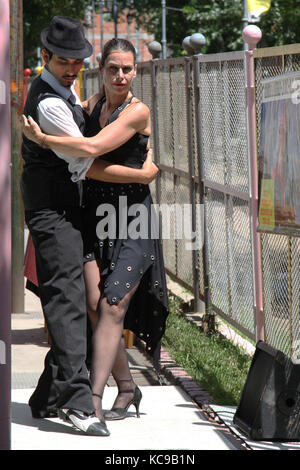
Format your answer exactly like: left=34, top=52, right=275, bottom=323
left=86, top=149, right=159, bottom=184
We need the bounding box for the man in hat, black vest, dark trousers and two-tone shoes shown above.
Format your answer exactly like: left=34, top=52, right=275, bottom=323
left=21, top=16, right=155, bottom=436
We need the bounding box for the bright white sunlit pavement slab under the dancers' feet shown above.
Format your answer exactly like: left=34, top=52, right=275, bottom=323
left=12, top=386, right=240, bottom=450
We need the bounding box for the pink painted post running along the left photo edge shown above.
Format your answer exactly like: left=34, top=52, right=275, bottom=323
left=0, top=0, right=11, bottom=450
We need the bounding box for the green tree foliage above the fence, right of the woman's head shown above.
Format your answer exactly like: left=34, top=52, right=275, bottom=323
left=118, top=0, right=300, bottom=56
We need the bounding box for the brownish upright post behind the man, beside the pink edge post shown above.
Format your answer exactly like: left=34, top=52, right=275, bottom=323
left=10, top=0, right=24, bottom=313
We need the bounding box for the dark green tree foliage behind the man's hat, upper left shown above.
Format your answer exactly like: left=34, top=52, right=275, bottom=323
left=23, top=0, right=91, bottom=67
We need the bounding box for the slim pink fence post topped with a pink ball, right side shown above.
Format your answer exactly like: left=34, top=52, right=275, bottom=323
left=243, top=25, right=264, bottom=340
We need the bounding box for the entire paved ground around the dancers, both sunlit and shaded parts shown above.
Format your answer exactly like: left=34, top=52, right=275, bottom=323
left=11, top=282, right=300, bottom=452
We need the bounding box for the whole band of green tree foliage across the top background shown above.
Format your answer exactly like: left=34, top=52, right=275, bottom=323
left=23, top=0, right=300, bottom=67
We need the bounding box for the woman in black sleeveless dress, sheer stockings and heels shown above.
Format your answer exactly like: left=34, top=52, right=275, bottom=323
left=23, top=39, right=168, bottom=420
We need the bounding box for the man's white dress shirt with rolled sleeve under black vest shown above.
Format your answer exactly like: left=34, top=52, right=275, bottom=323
left=37, top=67, right=94, bottom=182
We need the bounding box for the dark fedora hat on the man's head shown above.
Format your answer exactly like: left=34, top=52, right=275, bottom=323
left=41, top=16, right=93, bottom=59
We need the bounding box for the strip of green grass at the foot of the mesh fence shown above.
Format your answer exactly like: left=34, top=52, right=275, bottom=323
left=163, top=313, right=251, bottom=405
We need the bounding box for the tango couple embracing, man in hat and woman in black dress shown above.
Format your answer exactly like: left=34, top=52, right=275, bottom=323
left=21, top=16, right=168, bottom=436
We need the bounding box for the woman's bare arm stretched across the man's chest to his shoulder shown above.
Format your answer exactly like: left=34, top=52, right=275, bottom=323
left=23, top=102, right=150, bottom=157
